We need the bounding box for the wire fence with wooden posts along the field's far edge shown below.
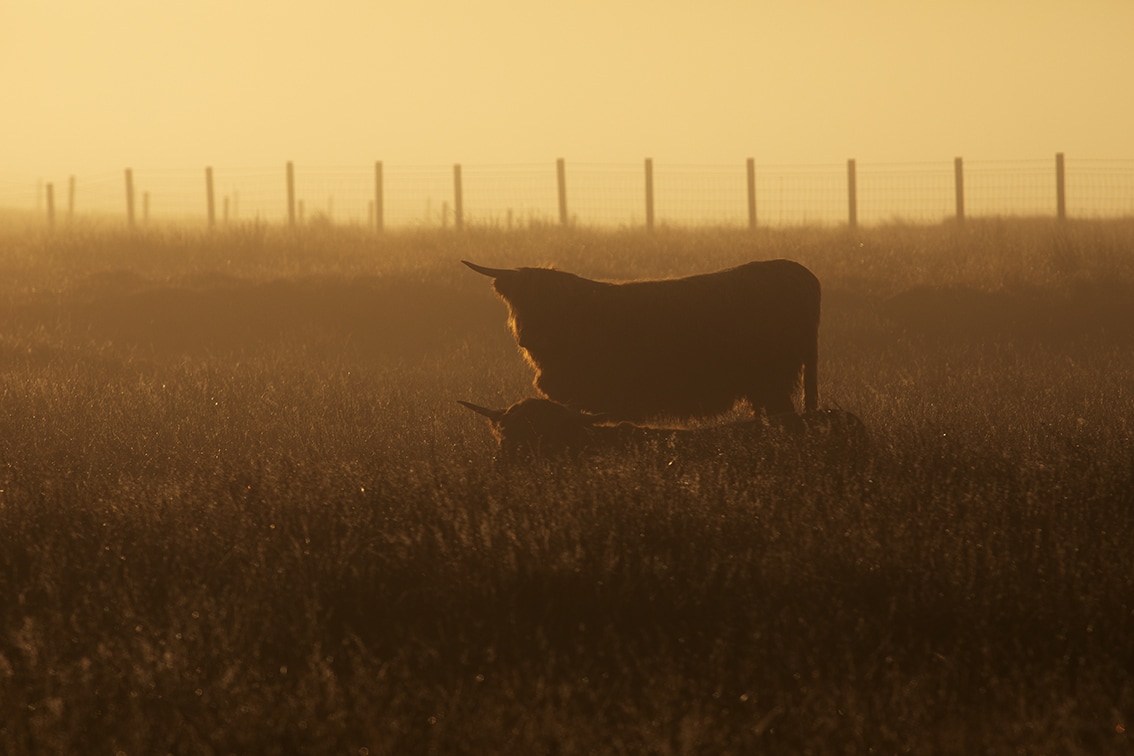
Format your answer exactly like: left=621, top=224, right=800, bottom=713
left=0, top=154, right=1134, bottom=229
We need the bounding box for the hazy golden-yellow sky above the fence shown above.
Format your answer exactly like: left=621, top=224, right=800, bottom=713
left=0, top=0, right=1134, bottom=184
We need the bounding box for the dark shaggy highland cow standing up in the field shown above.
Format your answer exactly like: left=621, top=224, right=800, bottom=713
left=463, top=260, right=820, bottom=421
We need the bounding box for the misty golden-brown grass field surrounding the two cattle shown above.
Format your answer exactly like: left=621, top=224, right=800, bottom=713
left=0, top=220, right=1134, bottom=754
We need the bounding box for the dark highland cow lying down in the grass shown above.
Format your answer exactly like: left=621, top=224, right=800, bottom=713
left=460, top=398, right=869, bottom=461
